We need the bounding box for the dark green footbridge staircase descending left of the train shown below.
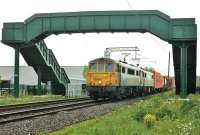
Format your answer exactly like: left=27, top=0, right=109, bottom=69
left=20, top=40, right=69, bottom=94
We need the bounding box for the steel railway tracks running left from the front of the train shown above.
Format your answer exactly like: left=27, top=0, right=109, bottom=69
left=0, top=98, right=105, bottom=124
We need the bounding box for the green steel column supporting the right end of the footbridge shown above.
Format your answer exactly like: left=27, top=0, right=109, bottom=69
left=180, top=44, right=187, bottom=98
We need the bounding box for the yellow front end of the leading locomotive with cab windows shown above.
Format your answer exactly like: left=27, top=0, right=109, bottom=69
left=86, top=58, right=119, bottom=99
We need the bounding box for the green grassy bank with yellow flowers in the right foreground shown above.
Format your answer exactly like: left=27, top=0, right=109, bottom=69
left=50, top=91, right=200, bottom=135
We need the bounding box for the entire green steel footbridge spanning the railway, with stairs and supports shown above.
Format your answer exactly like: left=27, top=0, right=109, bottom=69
left=2, top=10, right=197, bottom=97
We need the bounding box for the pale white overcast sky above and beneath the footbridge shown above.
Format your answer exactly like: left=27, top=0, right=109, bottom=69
left=0, top=0, right=200, bottom=75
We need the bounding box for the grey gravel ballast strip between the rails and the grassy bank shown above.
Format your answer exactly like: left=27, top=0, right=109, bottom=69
left=0, top=99, right=140, bottom=135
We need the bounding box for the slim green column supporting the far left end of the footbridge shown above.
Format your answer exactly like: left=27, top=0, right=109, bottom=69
left=14, top=47, right=20, bottom=97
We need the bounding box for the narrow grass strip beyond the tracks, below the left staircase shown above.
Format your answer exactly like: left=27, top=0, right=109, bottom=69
left=0, top=95, right=65, bottom=105
